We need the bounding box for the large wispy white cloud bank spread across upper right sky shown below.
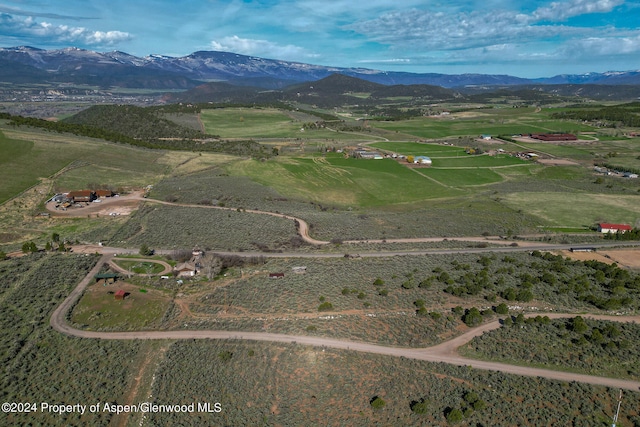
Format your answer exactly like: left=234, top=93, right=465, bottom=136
left=344, top=0, right=624, bottom=51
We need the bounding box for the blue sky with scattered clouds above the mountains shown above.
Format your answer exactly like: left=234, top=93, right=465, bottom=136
left=0, top=0, right=640, bottom=77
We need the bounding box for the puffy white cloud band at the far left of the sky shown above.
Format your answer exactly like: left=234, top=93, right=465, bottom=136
left=0, top=14, right=131, bottom=46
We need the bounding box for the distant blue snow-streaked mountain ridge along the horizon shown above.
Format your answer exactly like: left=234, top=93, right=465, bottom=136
left=0, top=46, right=640, bottom=89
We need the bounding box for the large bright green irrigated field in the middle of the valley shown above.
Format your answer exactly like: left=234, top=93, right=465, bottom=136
left=228, top=156, right=463, bottom=207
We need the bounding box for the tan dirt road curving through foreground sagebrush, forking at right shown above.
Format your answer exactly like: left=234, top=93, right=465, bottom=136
left=50, top=255, right=640, bottom=391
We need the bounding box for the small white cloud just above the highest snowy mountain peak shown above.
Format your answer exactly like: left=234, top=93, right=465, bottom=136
left=211, top=35, right=318, bottom=60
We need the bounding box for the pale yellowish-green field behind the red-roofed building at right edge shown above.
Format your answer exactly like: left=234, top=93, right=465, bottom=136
left=504, top=192, right=640, bottom=227
